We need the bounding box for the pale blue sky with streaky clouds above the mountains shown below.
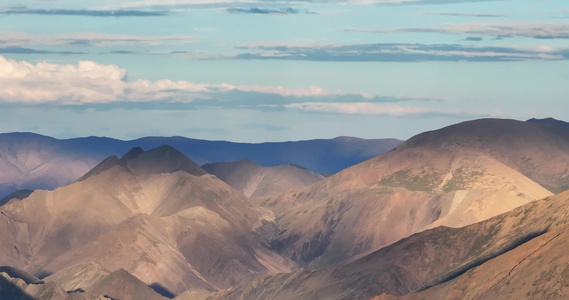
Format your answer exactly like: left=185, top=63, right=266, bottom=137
left=0, top=0, right=569, bottom=142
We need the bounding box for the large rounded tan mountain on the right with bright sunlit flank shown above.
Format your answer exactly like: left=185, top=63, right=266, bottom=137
left=260, top=119, right=569, bottom=268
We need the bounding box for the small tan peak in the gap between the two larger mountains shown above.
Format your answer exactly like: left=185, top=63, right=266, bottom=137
left=202, top=159, right=324, bottom=197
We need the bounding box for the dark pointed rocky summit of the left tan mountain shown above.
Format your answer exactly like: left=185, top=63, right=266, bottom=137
left=120, top=145, right=207, bottom=176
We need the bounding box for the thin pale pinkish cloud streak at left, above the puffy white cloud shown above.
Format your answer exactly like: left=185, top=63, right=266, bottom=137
left=0, top=31, right=199, bottom=47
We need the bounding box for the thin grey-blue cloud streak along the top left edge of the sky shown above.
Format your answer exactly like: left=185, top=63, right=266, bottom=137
left=0, top=5, right=170, bottom=17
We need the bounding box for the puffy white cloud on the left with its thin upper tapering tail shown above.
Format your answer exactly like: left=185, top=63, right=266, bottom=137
left=0, top=56, right=368, bottom=104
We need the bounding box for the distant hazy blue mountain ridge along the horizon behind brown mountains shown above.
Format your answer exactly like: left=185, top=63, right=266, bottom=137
left=0, top=133, right=401, bottom=199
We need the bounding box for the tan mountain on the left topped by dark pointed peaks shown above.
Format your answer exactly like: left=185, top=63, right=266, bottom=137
left=0, top=147, right=295, bottom=294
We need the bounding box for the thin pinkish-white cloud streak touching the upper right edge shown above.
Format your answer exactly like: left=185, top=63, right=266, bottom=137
left=346, top=22, right=569, bottom=39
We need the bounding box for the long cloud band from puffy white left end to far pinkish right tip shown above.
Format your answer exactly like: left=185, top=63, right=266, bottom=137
left=0, top=56, right=458, bottom=116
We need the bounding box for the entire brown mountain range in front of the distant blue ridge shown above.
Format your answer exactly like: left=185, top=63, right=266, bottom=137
left=0, top=119, right=569, bottom=300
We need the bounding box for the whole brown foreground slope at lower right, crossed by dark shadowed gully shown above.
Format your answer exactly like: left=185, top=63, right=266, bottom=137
left=207, top=191, right=569, bottom=300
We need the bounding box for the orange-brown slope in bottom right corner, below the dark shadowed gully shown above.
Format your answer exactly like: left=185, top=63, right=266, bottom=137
left=373, top=225, right=569, bottom=300
